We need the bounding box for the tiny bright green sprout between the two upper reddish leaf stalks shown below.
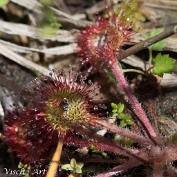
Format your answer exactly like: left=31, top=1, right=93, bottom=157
left=111, top=103, right=134, bottom=127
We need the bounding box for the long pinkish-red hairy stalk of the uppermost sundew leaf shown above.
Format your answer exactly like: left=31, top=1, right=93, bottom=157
left=110, top=60, right=158, bottom=144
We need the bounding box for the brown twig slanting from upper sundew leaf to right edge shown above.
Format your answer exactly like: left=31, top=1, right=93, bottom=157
left=117, top=25, right=177, bottom=60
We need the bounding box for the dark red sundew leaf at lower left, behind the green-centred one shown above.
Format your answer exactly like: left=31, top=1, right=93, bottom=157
left=4, top=109, right=59, bottom=165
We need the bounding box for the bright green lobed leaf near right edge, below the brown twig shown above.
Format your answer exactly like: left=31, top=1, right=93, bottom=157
left=153, top=53, right=175, bottom=76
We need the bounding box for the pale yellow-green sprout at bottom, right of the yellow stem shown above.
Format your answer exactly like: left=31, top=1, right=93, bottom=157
left=61, top=158, right=84, bottom=177
